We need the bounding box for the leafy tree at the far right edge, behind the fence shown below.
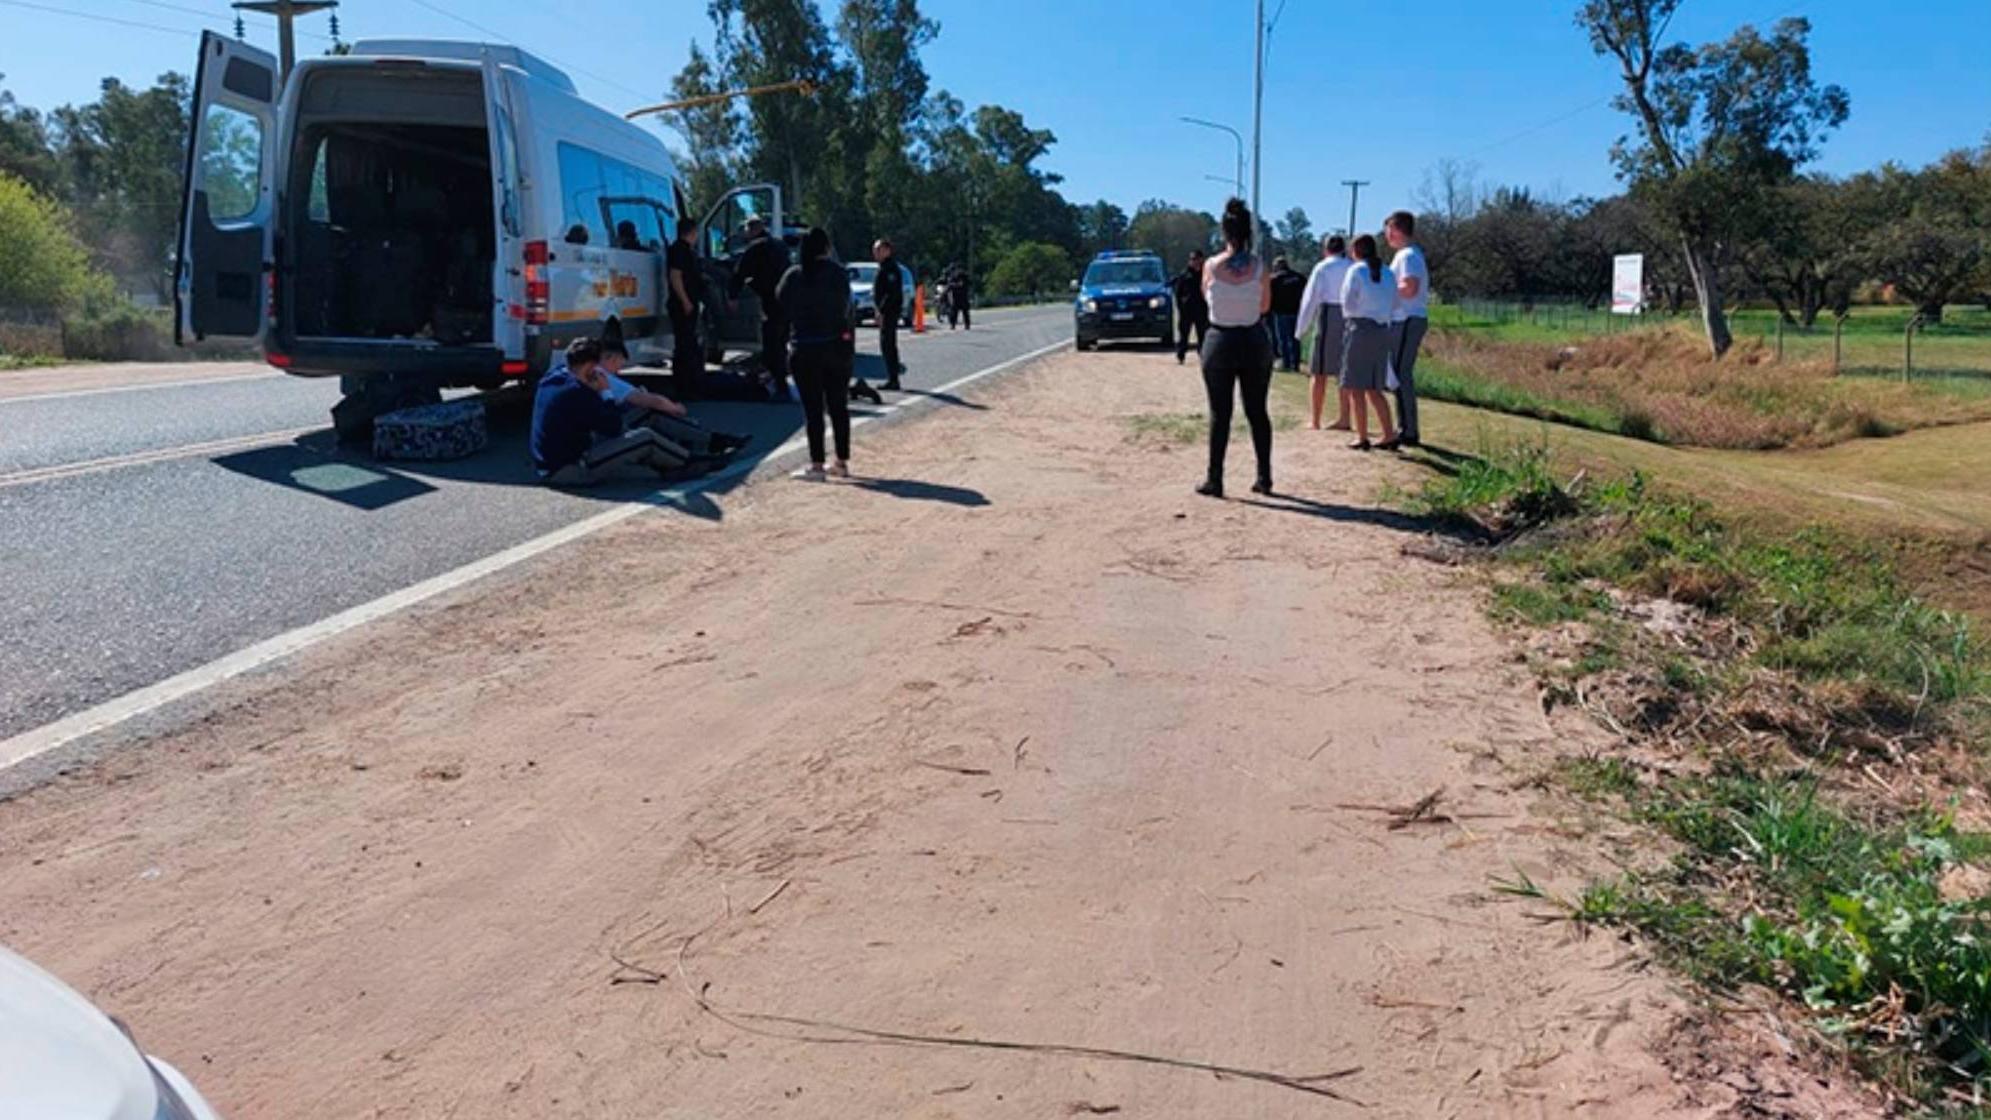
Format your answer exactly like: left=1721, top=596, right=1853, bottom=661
left=1864, top=143, right=1991, bottom=322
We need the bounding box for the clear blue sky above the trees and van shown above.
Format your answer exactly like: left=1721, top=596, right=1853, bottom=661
left=0, top=0, right=1991, bottom=227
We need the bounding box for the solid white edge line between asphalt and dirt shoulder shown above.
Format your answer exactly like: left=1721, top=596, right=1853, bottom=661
left=0, top=332, right=1071, bottom=770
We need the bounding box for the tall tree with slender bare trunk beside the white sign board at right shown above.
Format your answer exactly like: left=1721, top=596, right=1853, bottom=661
left=1577, top=0, right=1850, bottom=358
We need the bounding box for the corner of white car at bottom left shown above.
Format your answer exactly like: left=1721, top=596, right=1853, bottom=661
left=0, top=947, right=221, bottom=1120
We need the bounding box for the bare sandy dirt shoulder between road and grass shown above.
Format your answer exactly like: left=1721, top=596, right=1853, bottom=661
left=0, top=352, right=1862, bottom=1120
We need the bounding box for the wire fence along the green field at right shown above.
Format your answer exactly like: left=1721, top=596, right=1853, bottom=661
left=1432, top=298, right=1991, bottom=378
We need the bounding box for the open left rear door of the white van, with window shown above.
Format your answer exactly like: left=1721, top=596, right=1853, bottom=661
left=173, top=32, right=283, bottom=346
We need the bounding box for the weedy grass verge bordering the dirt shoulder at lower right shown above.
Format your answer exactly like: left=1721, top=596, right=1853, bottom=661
left=1410, top=437, right=1991, bottom=1116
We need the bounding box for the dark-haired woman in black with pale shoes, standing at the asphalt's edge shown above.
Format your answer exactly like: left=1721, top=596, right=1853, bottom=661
left=774, top=227, right=856, bottom=481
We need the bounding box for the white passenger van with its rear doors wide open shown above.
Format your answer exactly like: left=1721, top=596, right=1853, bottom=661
left=173, top=32, right=786, bottom=388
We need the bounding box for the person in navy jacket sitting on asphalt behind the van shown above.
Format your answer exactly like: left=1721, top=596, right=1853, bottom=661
left=530, top=338, right=744, bottom=485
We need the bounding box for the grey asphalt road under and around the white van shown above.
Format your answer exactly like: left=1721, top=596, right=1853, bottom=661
left=0, top=306, right=1071, bottom=740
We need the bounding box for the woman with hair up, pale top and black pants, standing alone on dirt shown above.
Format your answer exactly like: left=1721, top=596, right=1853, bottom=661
left=1197, top=199, right=1272, bottom=497
